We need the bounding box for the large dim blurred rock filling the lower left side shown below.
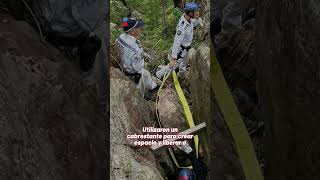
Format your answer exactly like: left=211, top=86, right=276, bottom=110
left=0, top=15, right=106, bottom=180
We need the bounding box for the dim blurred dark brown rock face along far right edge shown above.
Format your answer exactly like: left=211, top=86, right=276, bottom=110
left=256, top=0, right=320, bottom=180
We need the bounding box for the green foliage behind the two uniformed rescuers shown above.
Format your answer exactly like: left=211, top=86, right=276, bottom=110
left=110, top=0, right=200, bottom=68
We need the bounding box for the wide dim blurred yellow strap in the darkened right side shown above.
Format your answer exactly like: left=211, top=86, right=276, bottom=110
left=210, top=44, right=263, bottom=180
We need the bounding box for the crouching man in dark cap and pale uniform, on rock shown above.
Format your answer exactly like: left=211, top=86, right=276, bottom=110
left=116, top=18, right=161, bottom=98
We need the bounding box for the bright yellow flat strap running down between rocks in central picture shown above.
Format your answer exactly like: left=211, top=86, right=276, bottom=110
left=172, top=71, right=199, bottom=158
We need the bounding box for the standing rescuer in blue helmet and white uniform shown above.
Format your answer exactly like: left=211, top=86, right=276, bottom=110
left=156, top=2, right=202, bottom=79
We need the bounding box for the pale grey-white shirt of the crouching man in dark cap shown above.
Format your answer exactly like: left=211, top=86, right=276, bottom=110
left=116, top=33, right=144, bottom=73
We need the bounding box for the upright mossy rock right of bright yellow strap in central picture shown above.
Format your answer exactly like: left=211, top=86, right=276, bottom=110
left=189, top=45, right=213, bottom=170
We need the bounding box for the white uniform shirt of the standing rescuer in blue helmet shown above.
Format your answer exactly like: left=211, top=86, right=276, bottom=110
left=171, top=14, right=202, bottom=59
